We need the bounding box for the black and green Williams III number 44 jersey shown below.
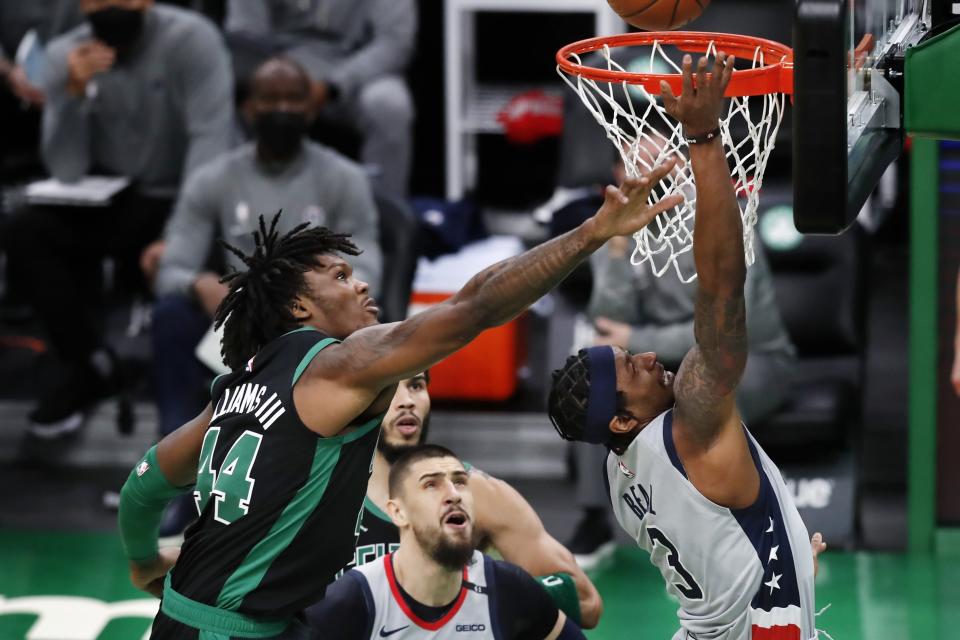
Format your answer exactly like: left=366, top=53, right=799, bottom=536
left=172, top=329, right=382, bottom=618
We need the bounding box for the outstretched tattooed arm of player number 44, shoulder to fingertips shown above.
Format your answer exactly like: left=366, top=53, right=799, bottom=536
left=297, top=161, right=680, bottom=436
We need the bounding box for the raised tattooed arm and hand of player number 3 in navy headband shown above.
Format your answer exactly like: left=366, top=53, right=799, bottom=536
left=664, top=54, right=747, bottom=445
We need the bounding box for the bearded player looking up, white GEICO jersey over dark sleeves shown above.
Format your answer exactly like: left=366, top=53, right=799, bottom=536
left=308, top=445, right=584, bottom=640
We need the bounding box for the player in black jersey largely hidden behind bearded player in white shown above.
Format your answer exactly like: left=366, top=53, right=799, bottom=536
left=344, top=371, right=603, bottom=629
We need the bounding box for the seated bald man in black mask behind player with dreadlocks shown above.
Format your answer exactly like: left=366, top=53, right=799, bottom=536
left=141, top=57, right=381, bottom=533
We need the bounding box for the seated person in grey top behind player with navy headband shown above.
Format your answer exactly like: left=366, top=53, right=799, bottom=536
left=569, top=226, right=796, bottom=568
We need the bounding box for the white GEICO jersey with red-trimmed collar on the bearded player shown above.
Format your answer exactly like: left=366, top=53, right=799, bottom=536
left=354, top=551, right=500, bottom=640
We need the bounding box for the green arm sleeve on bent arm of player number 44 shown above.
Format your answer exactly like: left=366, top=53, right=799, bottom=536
left=117, top=445, right=189, bottom=564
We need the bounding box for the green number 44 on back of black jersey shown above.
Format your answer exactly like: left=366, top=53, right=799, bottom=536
left=193, top=427, right=263, bottom=524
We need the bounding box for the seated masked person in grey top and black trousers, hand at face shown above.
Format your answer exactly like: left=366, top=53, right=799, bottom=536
left=4, top=0, right=233, bottom=438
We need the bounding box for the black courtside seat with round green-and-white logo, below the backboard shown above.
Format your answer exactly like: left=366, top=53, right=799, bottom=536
left=750, top=207, right=865, bottom=449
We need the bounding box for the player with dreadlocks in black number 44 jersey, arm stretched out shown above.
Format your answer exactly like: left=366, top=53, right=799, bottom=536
left=119, top=149, right=681, bottom=640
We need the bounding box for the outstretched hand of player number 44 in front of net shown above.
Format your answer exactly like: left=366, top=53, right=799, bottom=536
left=593, top=158, right=683, bottom=242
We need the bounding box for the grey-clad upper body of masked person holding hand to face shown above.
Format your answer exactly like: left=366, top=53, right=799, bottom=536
left=43, top=0, right=234, bottom=197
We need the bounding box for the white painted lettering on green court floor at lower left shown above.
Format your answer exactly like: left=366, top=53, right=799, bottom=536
left=0, top=596, right=160, bottom=640
